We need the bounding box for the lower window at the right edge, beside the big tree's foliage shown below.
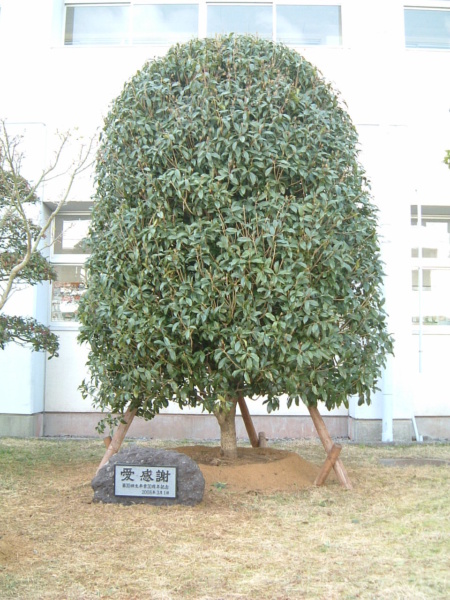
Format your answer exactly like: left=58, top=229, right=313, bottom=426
left=411, top=206, right=450, bottom=333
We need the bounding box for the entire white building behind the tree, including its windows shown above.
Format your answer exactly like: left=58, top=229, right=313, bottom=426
left=0, top=0, right=450, bottom=441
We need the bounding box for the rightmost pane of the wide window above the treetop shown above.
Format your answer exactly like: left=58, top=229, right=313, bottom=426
left=276, top=5, right=341, bottom=46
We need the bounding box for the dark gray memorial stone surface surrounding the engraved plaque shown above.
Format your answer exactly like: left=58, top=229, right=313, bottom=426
left=91, top=446, right=205, bottom=506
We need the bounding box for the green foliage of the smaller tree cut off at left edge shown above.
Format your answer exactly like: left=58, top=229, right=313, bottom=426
left=0, top=150, right=58, bottom=356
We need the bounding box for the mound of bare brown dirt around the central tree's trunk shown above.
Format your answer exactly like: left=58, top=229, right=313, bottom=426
left=173, top=446, right=319, bottom=494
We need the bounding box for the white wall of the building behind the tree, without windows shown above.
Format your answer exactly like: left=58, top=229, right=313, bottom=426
left=0, top=0, right=450, bottom=439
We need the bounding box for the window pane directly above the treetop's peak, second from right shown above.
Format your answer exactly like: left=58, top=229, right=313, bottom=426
left=207, top=4, right=273, bottom=39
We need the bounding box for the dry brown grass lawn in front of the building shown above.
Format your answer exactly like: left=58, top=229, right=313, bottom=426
left=0, top=439, right=450, bottom=600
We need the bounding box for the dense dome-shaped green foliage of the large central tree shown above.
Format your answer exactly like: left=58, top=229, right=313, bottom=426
left=79, top=36, right=392, bottom=418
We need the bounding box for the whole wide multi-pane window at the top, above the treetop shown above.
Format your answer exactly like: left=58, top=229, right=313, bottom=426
left=64, top=0, right=342, bottom=46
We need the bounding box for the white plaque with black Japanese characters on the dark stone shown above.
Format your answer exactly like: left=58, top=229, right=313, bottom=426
left=114, top=465, right=177, bottom=498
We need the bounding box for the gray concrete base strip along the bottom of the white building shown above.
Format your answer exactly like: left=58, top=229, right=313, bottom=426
left=0, top=412, right=450, bottom=443
